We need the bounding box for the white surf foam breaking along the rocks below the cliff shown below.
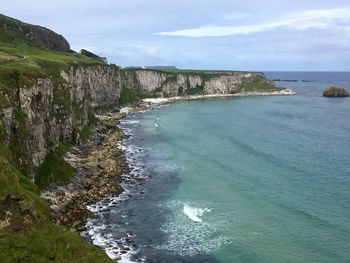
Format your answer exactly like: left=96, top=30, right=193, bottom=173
left=82, top=119, right=154, bottom=263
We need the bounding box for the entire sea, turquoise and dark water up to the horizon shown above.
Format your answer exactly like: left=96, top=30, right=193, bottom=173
left=83, top=72, right=350, bottom=263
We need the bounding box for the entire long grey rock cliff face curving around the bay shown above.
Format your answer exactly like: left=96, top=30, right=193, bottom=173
left=0, top=65, right=274, bottom=182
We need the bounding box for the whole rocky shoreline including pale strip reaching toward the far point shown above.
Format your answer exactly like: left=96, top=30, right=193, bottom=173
left=41, top=89, right=295, bottom=262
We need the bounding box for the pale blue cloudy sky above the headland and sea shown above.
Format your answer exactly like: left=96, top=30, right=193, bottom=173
left=0, top=0, right=350, bottom=71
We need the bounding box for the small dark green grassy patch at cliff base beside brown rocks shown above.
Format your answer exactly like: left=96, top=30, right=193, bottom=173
left=35, top=144, right=76, bottom=189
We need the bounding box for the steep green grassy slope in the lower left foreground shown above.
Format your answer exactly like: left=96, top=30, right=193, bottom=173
left=0, top=144, right=111, bottom=263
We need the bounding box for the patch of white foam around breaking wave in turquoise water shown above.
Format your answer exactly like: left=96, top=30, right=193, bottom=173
left=156, top=200, right=233, bottom=257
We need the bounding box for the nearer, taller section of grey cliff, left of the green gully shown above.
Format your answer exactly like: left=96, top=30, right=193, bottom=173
left=0, top=66, right=121, bottom=179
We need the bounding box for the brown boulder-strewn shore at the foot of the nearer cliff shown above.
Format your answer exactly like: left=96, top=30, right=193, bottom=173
left=41, top=112, right=129, bottom=231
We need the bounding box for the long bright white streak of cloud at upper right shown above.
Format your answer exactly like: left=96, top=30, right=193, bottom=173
left=155, top=8, right=350, bottom=37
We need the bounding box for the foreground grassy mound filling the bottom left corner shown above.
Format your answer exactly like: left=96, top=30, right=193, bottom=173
left=0, top=225, right=114, bottom=263
